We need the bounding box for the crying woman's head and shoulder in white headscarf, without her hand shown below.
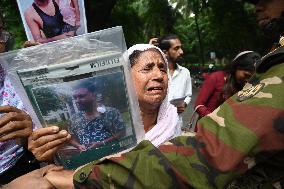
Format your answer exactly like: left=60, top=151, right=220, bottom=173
left=128, top=44, right=181, bottom=146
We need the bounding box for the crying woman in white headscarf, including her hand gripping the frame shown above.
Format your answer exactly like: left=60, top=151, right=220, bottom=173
left=29, top=44, right=181, bottom=161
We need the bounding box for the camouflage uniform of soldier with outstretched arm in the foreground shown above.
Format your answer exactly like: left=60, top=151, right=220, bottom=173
left=74, top=47, right=284, bottom=189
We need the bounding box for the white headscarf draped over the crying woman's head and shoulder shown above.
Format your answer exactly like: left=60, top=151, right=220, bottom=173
left=127, top=44, right=181, bottom=146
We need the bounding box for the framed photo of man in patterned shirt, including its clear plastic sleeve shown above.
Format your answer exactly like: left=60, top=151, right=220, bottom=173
left=0, top=26, right=145, bottom=169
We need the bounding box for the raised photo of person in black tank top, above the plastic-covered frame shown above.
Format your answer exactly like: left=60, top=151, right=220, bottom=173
left=17, top=0, right=87, bottom=43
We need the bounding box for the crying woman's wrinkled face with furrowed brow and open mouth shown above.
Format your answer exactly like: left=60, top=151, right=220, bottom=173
left=131, top=49, right=168, bottom=108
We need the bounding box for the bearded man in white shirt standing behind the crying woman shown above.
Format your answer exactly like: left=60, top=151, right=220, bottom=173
left=156, top=34, right=192, bottom=114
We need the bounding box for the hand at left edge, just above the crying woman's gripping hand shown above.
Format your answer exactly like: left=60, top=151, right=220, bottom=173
left=0, top=106, right=33, bottom=142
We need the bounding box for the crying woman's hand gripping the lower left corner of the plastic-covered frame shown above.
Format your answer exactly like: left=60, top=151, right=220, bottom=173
left=28, top=126, right=71, bottom=161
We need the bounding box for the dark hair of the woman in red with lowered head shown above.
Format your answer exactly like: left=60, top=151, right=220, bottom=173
left=223, top=51, right=261, bottom=99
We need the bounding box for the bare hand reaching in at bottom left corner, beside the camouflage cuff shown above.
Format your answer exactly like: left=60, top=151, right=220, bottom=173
left=2, top=165, right=57, bottom=189
